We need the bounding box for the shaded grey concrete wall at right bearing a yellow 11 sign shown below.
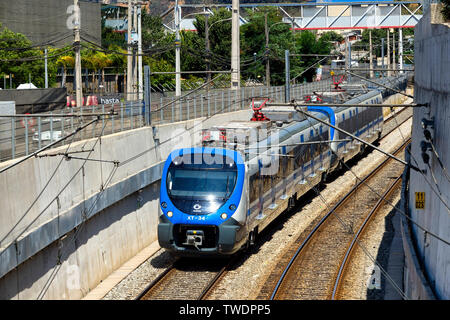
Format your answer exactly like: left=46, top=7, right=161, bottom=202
left=405, top=4, right=450, bottom=299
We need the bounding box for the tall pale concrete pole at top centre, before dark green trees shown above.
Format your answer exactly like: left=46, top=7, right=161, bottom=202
left=231, top=0, right=241, bottom=92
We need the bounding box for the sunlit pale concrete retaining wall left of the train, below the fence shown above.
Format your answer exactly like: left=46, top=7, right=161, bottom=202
left=0, top=110, right=251, bottom=299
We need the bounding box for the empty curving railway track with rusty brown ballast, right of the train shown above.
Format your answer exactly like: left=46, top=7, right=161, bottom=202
left=258, top=141, right=409, bottom=300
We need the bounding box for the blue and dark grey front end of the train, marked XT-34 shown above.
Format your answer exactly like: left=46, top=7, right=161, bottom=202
left=158, top=148, right=247, bottom=257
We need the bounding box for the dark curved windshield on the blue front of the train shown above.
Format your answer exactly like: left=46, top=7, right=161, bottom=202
left=167, top=154, right=237, bottom=214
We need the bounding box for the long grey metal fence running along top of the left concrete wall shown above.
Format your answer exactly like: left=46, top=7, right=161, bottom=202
left=0, top=79, right=332, bottom=161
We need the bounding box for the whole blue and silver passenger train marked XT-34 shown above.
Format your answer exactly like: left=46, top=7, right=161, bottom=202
left=158, top=90, right=383, bottom=257
